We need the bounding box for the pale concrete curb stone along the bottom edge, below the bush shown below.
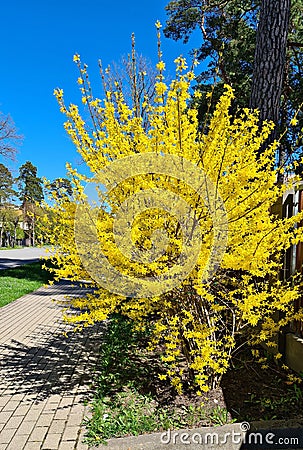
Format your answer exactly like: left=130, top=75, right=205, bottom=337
left=90, top=419, right=303, bottom=450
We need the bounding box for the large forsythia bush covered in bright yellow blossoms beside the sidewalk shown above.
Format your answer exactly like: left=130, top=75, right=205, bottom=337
left=45, top=44, right=302, bottom=393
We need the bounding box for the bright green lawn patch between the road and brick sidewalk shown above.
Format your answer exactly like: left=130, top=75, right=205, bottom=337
left=0, top=261, right=51, bottom=307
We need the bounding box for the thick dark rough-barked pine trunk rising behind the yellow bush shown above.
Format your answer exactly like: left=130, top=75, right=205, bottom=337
left=250, top=0, right=290, bottom=142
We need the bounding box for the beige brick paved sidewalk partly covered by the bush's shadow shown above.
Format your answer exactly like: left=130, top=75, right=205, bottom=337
left=0, top=282, right=102, bottom=450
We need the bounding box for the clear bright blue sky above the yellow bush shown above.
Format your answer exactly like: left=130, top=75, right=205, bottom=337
left=0, top=0, right=201, bottom=183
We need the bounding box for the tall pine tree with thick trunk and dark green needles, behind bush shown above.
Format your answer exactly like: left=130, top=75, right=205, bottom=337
left=164, top=0, right=303, bottom=162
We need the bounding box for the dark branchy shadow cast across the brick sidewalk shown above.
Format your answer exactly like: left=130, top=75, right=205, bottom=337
left=0, top=323, right=104, bottom=402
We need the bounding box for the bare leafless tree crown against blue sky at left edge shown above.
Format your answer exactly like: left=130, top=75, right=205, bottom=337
left=0, top=112, right=22, bottom=159
